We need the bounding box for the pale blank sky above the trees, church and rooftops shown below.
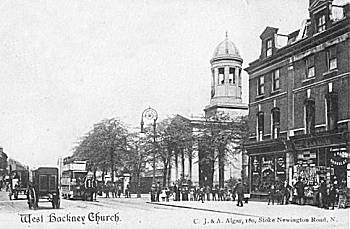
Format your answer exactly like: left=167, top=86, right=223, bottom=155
left=0, top=0, right=308, bottom=167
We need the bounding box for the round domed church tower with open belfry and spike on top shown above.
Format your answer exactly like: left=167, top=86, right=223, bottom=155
left=204, top=33, right=248, bottom=117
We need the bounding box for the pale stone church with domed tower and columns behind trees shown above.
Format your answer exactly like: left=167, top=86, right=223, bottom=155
left=170, top=33, right=248, bottom=186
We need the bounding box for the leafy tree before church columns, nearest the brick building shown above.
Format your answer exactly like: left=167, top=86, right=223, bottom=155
left=196, top=114, right=248, bottom=187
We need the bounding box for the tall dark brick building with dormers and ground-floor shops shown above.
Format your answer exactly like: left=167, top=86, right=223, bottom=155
left=245, top=0, right=350, bottom=199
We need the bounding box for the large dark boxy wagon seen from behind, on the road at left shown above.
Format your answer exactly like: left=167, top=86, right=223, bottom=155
left=27, top=167, right=60, bottom=210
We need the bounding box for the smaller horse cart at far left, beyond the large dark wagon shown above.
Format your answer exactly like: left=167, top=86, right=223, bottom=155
left=9, top=170, right=29, bottom=200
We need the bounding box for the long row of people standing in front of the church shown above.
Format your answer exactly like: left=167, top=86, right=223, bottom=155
left=151, top=179, right=248, bottom=206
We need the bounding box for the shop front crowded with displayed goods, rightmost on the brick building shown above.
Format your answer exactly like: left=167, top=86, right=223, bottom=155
left=291, top=132, right=349, bottom=205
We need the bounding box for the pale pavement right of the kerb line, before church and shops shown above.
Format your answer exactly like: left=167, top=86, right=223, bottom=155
left=147, top=198, right=350, bottom=229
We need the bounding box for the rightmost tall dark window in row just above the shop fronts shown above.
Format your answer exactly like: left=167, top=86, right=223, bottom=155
left=326, top=92, right=338, bottom=130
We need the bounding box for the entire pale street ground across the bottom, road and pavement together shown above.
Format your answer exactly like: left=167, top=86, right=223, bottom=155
left=0, top=191, right=349, bottom=229
